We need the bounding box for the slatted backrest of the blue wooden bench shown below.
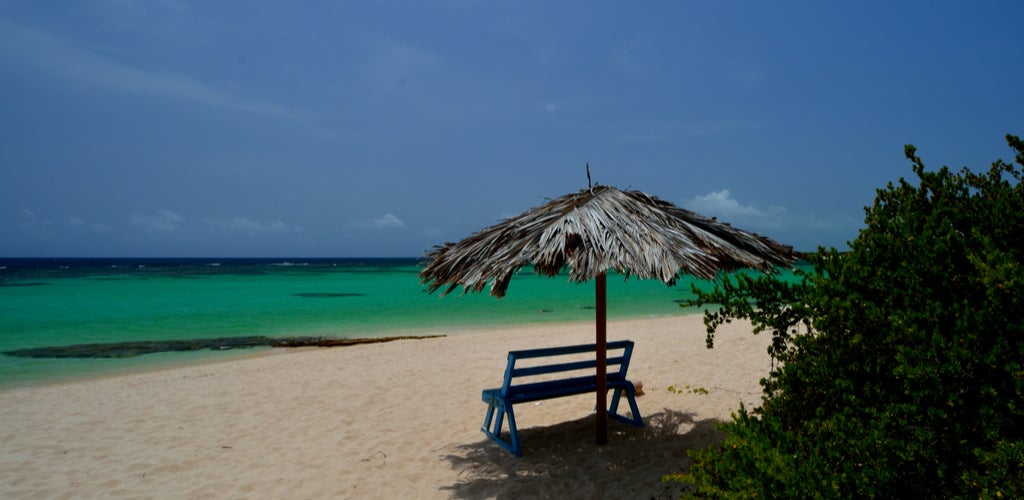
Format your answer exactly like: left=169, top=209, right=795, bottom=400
left=502, top=340, right=633, bottom=394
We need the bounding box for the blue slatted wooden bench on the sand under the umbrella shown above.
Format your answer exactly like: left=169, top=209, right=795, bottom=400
left=481, top=340, right=643, bottom=457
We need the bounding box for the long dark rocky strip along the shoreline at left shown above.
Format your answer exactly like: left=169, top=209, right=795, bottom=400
left=3, top=335, right=444, bottom=358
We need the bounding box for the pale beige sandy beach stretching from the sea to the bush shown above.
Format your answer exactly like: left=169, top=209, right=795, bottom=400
left=0, top=316, right=770, bottom=498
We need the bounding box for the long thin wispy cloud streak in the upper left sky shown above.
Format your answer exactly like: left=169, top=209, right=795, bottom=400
left=0, top=20, right=303, bottom=120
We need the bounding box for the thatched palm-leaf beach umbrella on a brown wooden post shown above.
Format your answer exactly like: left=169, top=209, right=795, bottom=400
left=420, top=185, right=796, bottom=444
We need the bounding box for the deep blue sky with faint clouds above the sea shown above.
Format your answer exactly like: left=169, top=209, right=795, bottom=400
left=0, top=0, right=1024, bottom=257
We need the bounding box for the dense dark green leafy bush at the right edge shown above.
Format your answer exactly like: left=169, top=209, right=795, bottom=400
left=668, top=135, right=1024, bottom=498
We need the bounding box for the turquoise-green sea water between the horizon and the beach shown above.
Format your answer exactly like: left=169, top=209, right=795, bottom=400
left=0, top=259, right=798, bottom=387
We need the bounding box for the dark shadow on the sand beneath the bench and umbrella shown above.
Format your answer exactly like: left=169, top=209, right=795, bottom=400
left=445, top=409, right=723, bottom=499
